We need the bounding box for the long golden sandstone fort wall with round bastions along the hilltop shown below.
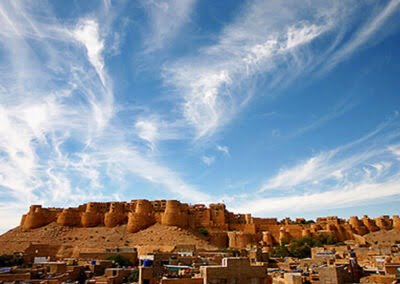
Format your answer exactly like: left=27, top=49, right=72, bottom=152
left=21, top=199, right=400, bottom=248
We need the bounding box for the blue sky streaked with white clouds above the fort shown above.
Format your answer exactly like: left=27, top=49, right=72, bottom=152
left=0, top=0, right=400, bottom=231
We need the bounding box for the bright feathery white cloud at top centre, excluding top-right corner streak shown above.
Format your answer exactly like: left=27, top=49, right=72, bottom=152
left=165, top=1, right=329, bottom=138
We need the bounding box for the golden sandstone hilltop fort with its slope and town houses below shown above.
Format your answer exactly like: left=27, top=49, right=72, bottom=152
left=0, top=199, right=400, bottom=284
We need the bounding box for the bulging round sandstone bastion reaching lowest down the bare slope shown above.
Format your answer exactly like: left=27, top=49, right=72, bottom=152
left=127, top=199, right=155, bottom=233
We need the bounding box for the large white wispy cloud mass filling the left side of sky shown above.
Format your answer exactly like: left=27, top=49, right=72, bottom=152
left=0, top=1, right=209, bottom=233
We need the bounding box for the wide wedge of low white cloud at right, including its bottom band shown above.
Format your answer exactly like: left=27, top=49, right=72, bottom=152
left=232, top=115, right=400, bottom=215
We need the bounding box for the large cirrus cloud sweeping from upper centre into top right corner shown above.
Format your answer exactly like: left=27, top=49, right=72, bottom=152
left=164, top=1, right=398, bottom=138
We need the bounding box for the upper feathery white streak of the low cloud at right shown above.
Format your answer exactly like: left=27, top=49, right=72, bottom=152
left=259, top=117, right=399, bottom=192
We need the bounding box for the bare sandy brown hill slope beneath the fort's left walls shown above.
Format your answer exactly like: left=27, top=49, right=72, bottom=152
left=0, top=222, right=216, bottom=257
